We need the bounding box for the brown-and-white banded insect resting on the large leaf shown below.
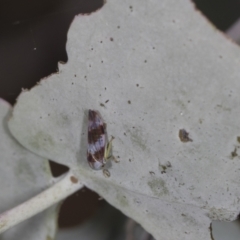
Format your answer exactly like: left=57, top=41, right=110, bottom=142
left=87, top=110, right=114, bottom=170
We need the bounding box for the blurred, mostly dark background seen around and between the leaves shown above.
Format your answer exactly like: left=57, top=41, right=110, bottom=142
left=0, top=0, right=240, bottom=240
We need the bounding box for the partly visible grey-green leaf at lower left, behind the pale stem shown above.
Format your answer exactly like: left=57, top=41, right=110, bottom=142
left=0, top=99, right=58, bottom=240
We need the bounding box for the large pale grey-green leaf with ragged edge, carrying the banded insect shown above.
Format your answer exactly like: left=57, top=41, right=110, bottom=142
left=9, top=0, right=240, bottom=240
